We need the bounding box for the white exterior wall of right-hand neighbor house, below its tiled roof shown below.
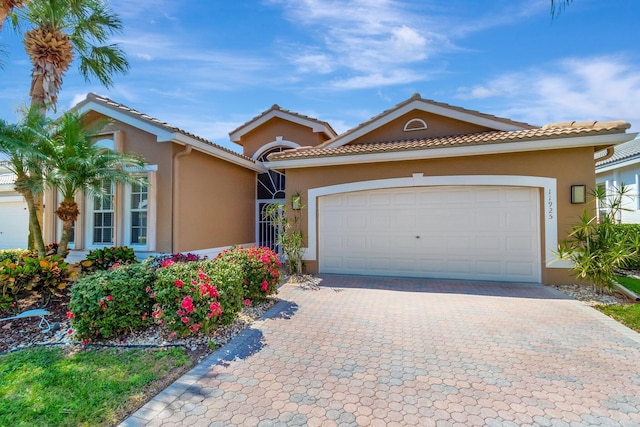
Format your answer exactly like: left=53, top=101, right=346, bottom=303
left=596, top=159, right=640, bottom=224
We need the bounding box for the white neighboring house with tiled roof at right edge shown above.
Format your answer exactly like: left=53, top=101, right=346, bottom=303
left=596, top=138, right=640, bottom=224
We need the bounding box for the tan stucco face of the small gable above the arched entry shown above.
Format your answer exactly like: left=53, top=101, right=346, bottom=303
left=240, top=117, right=327, bottom=157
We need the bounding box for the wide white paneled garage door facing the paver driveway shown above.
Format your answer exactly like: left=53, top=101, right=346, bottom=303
left=318, top=186, right=541, bottom=282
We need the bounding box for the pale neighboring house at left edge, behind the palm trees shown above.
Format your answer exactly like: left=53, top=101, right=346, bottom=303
left=0, top=158, right=29, bottom=249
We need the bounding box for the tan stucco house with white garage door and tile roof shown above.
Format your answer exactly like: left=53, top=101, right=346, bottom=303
left=0, top=94, right=635, bottom=283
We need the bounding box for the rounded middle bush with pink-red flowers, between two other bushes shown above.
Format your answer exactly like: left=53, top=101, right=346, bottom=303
left=152, top=260, right=243, bottom=335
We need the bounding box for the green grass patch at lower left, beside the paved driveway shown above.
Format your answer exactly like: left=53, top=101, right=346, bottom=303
left=0, top=347, right=190, bottom=426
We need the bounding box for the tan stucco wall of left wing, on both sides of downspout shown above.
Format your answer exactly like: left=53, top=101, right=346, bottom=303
left=59, top=112, right=256, bottom=253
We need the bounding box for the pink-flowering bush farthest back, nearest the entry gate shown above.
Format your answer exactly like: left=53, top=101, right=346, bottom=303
left=215, top=246, right=282, bottom=301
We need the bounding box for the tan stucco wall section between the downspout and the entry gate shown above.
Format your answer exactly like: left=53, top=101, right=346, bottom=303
left=175, top=147, right=256, bottom=251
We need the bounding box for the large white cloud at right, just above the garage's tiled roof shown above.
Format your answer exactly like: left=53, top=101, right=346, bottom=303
left=458, top=56, right=640, bottom=126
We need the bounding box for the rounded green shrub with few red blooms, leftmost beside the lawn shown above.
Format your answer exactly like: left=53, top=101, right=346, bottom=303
left=67, top=264, right=155, bottom=343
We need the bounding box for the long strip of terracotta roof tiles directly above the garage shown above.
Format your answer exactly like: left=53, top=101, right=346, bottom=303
left=268, top=121, right=631, bottom=161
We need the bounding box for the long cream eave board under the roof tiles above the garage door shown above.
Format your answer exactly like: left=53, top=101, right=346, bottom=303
left=265, top=133, right=637, bottom=170
